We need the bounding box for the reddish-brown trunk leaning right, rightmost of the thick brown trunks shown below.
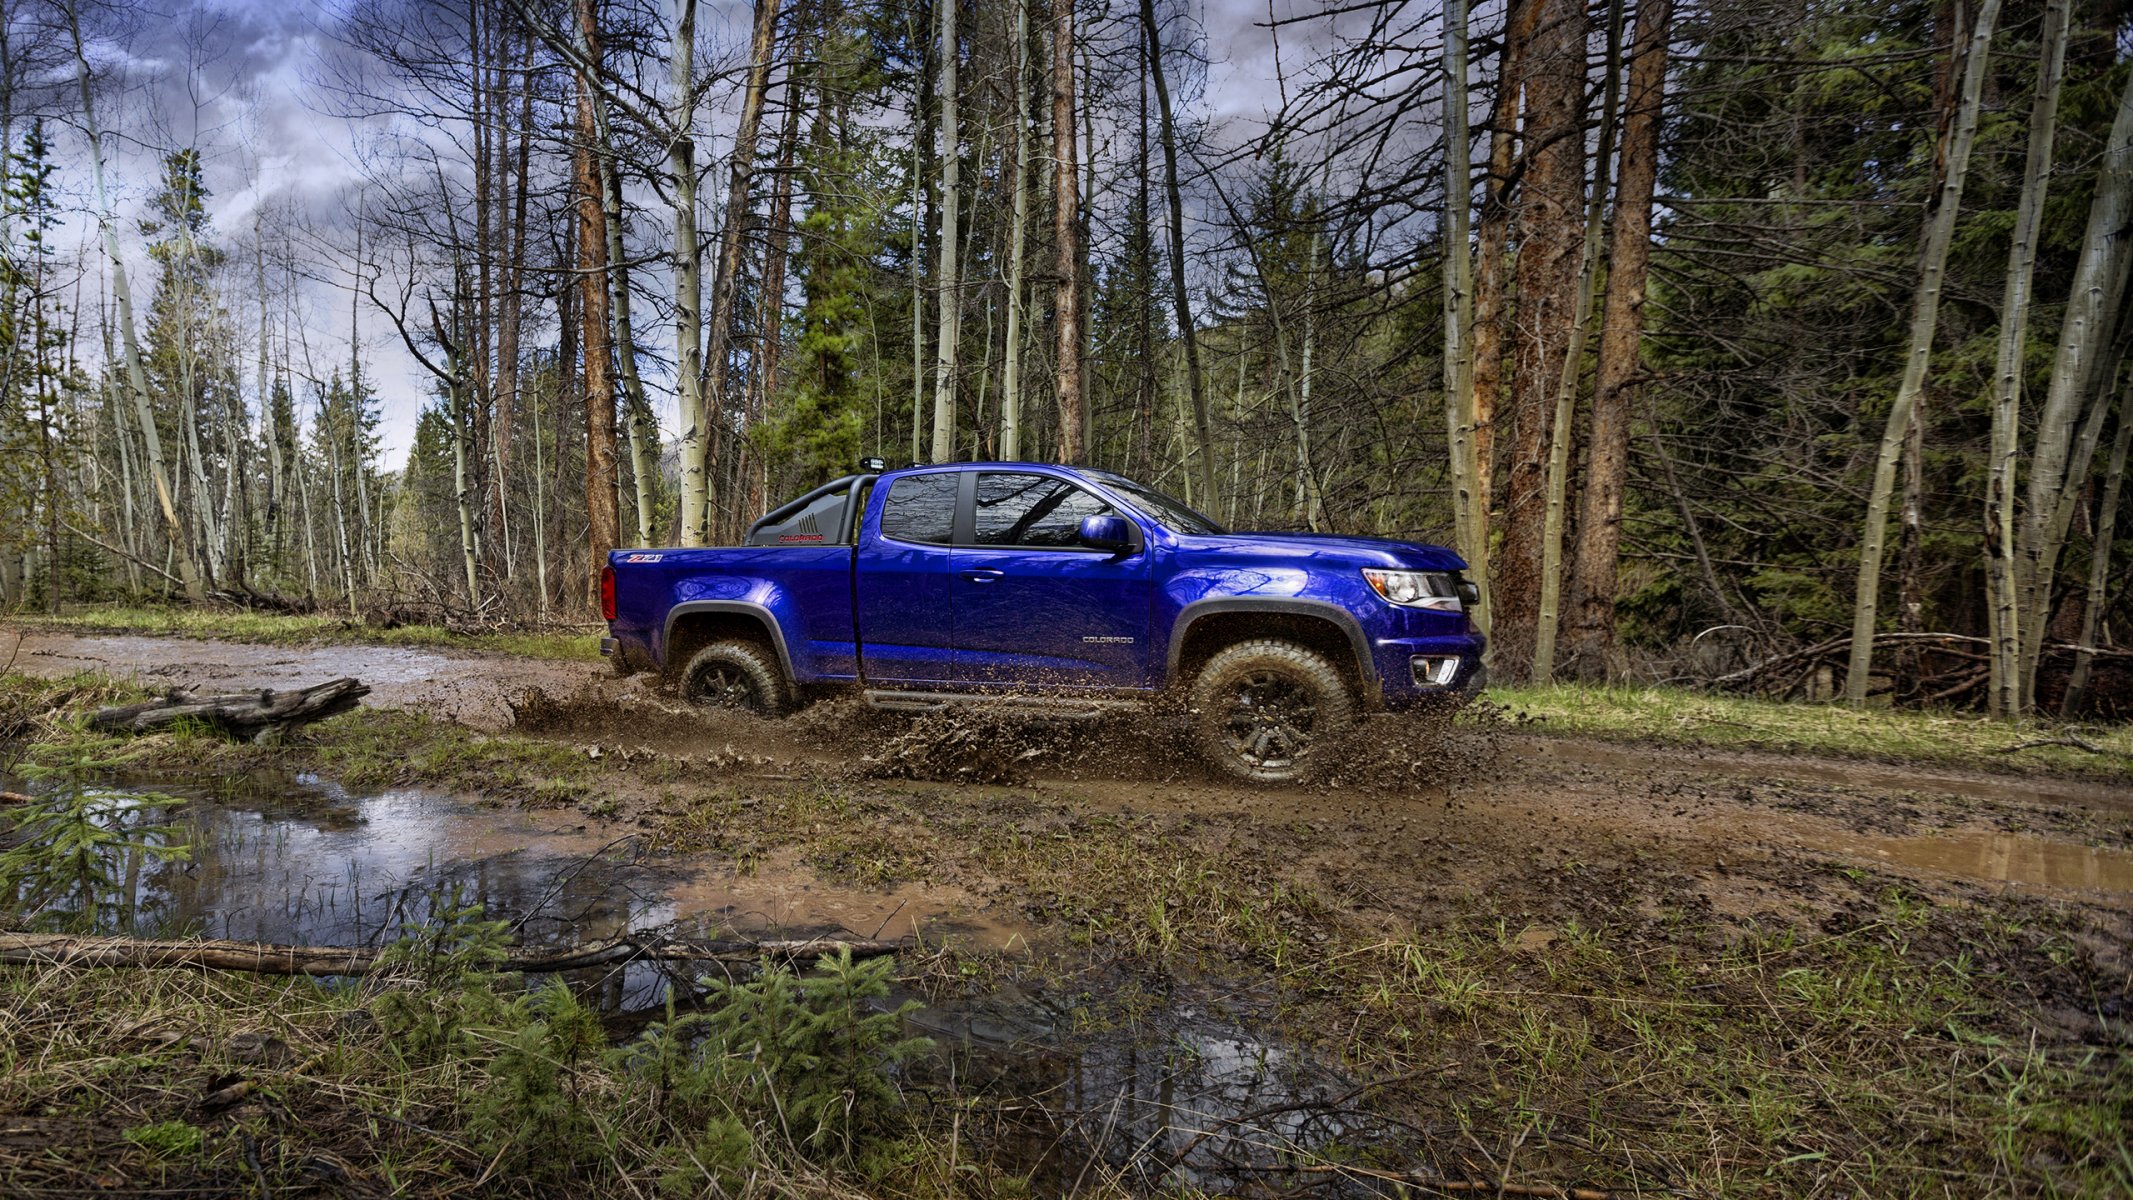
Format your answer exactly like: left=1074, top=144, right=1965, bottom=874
left=1570, top=0, right=1672, bottom=680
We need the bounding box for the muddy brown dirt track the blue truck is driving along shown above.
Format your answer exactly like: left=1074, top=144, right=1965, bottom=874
left=17, top=633, right=2133, bottom=921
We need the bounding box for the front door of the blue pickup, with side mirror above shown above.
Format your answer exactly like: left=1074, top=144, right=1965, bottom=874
left=949, top=471, right=1150, bottom=688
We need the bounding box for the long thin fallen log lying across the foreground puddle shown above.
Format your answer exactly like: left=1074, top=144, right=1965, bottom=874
left=0, top=934, right=911, bottom=974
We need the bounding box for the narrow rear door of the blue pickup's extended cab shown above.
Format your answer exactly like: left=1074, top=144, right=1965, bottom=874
left=853, top=471, right=960, bottom=684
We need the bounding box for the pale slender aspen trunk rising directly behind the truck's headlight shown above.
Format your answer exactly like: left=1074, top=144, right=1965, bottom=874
left=1444, top=0, right=1489, bottom=618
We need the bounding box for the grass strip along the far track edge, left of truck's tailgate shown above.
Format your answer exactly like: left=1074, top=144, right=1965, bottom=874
left=6, top=605, right=599, bottom=661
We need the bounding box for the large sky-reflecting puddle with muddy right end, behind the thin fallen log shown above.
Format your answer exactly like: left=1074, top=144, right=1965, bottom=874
left=2, top=774, right=1015, bottom=946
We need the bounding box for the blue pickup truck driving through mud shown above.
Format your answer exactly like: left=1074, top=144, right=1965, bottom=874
left=602, top=463, right=1482, bottom=782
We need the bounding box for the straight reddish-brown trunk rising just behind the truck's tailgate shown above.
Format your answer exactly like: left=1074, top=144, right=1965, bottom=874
left=572, top=0, right=621, bottom=607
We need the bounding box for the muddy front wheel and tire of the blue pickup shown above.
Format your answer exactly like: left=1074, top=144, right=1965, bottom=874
left=1186, top=637, right=1357, bottom=784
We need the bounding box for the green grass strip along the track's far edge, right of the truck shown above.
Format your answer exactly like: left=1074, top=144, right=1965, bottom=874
left=1489, top=684, right=2133, bottom=778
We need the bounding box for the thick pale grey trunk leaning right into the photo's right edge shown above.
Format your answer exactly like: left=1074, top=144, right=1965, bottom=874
left=2016, top=65, right=2133, bottom=712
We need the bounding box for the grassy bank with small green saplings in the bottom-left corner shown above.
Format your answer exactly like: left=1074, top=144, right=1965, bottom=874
left=0, top=908, right=1006, bottom=1198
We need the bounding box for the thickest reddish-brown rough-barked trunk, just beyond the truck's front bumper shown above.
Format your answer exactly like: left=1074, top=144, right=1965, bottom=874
left=1493, top=0, right=1587, bottom=678
